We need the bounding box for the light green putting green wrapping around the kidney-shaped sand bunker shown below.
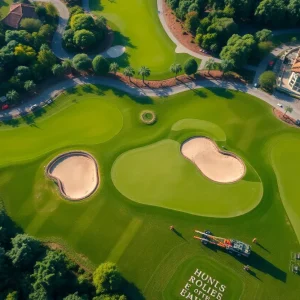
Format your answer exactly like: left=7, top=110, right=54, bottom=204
left=112, top=140, right=262, bottom=217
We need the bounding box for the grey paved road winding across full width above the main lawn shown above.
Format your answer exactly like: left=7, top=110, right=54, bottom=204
left=0, top=77, right=300, bottom=120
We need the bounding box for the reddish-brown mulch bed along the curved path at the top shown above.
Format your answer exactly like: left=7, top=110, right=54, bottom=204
left=163, top=0, right=209, bottom=56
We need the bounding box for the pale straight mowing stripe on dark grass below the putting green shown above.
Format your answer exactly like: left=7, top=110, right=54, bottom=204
left=106, top=218, right=143, bottom=262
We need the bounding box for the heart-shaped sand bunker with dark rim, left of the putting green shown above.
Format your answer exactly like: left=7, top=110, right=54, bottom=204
left=46, top=151, right=100, bottom=200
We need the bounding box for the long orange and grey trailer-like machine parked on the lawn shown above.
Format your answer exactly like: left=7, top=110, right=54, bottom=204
left=194, top=230, right=251, bottom=257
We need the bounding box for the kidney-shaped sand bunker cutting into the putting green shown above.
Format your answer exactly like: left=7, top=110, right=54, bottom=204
left=181, top=137, right=246, bottom=183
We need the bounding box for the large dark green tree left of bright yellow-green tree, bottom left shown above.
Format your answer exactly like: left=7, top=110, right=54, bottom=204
left=31, top=251, right=67, bottom=295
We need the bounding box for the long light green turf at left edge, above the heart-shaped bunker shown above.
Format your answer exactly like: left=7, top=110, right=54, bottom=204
left=0, top=96, right=123, bottom=165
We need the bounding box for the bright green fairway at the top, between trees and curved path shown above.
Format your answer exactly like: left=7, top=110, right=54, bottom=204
left=90, top=0, right=200, bottom=79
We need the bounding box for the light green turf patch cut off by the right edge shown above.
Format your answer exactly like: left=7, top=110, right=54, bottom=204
left=270, top=133, right=300, bottom=240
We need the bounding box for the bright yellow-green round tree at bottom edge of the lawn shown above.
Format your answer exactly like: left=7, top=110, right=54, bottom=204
left=93, top=262, right=124, bottom=294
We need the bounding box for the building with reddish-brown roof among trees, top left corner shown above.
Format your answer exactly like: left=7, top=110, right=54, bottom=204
left=2, top=3, right=38, bottom=29
